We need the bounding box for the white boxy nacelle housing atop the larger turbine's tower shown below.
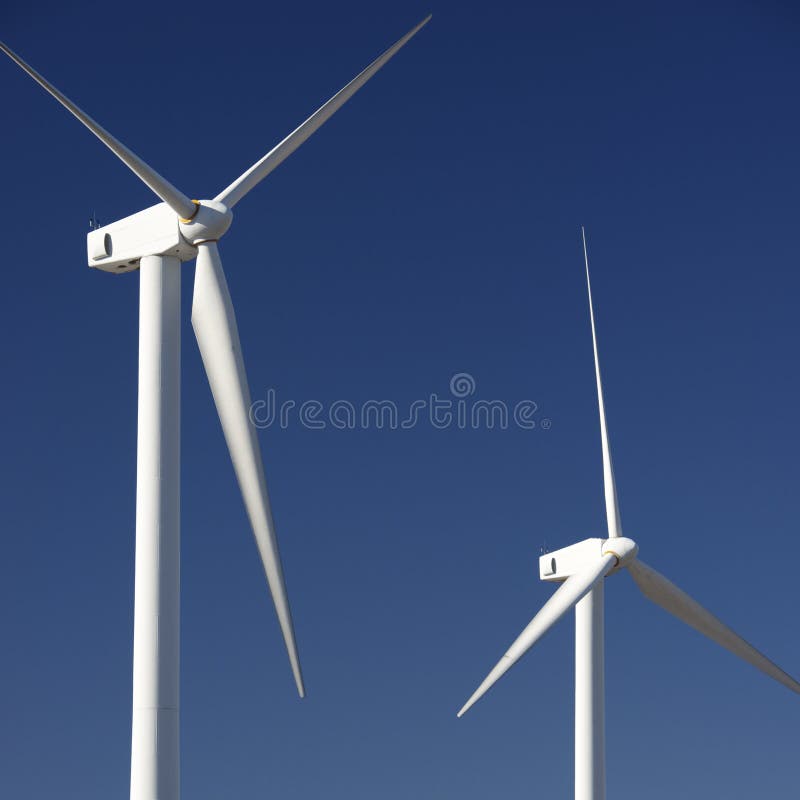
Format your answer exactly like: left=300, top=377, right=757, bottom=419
left=86, top=203, right=197, bottom=274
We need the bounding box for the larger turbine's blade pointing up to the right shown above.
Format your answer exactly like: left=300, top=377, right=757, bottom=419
left=214, top=15, right=424, bottom=208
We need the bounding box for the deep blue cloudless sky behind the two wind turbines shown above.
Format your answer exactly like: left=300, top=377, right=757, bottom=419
left=0, top=0, right=800, bottom=800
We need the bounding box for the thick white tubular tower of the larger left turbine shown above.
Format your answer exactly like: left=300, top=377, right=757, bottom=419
left=131, top=256, right=181, bottom=800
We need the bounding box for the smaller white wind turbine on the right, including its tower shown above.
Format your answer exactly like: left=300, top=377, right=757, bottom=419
left=458, top=228, right=800, bottom=800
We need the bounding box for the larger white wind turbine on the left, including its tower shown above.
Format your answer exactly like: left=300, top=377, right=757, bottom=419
left=0, top=16, right=430, bottom=800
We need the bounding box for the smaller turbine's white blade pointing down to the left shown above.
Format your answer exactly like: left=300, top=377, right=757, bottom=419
left=458, top=553, right=618, bottom=717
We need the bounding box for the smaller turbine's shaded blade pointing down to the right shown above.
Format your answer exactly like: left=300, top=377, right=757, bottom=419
left=627, top=560, right=800, bottom=694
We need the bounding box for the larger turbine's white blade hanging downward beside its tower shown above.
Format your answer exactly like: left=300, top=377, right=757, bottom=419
left=192, top=242, right=305, bottom=697
